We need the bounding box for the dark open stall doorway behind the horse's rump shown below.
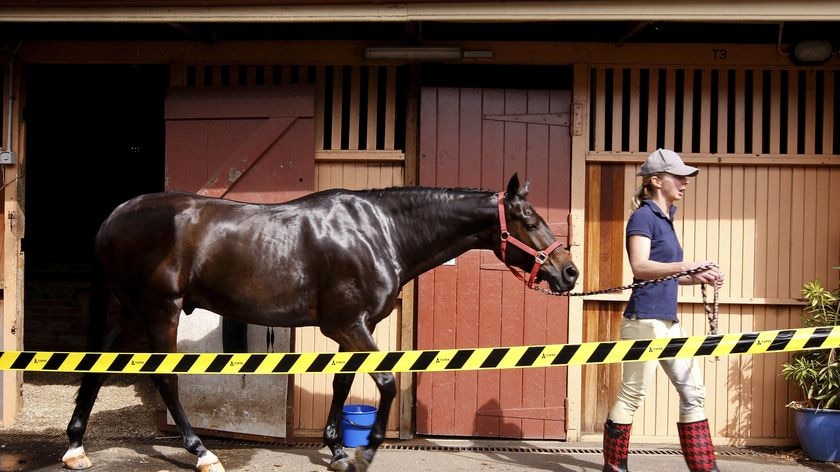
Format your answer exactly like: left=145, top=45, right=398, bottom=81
left=23, top=65, right=168, bottom=350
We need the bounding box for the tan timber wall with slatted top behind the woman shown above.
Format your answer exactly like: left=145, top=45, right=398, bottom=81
left=581, top=66, right=840, bottom=445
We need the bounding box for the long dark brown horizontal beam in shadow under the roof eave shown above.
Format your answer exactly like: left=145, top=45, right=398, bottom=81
left=18, top=41, right=840, bottom=68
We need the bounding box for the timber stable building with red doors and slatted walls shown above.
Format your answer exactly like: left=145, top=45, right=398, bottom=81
left=0, top=0, right=840, bottom=445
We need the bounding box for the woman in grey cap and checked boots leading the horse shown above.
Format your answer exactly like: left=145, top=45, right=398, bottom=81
left=604, top=149, right=724, bottom=472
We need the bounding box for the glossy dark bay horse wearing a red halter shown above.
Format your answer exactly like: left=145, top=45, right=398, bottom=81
left=62, top=174, right=578, bottom=472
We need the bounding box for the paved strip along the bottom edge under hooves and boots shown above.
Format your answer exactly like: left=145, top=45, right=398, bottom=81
left=0, top=431, right=840, bottom=472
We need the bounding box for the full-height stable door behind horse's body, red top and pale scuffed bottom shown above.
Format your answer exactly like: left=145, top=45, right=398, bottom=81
left=165, top=86, right=315, bottom=437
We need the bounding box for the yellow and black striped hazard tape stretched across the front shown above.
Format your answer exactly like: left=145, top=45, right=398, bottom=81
left=0, top=326, right=840, bottom=374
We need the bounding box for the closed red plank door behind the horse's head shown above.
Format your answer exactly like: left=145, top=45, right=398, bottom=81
left=416, top=88, right=571, bottom=439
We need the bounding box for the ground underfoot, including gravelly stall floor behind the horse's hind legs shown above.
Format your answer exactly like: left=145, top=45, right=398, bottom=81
left=6, top=372, right=840, bottom=472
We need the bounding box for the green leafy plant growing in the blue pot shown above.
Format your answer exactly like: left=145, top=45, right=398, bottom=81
left=782, top=267, right=840, bottom=409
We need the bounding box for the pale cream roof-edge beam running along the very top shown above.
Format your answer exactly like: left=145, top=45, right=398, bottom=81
left=0, top=0, right=840, bottom=23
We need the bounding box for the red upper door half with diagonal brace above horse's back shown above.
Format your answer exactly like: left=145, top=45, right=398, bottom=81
left=166, top=85, right=315, bottom=203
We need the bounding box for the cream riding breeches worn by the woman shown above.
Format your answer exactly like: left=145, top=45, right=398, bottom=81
left=609, top=318, right=706, bottom=424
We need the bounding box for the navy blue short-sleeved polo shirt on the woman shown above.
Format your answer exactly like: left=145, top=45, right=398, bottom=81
left=624, top=200, right=683, bottom=321
